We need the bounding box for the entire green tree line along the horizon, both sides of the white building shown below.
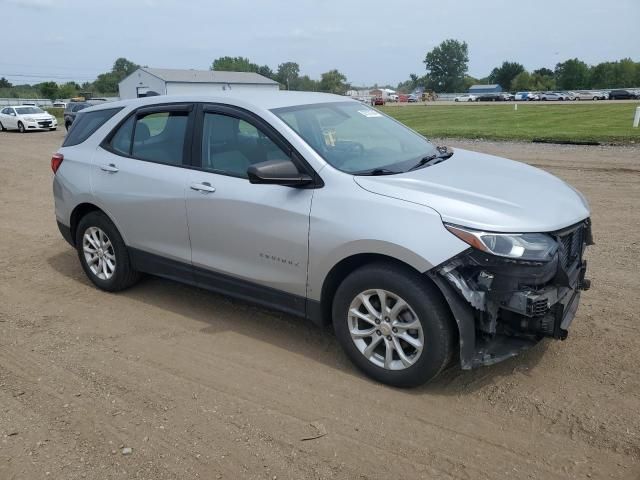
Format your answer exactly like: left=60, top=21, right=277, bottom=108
left=0, top=45, right=640, bottom=100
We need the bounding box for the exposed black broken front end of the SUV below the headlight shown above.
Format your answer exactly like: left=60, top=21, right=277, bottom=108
left=427, top=220, right=593, bottom=369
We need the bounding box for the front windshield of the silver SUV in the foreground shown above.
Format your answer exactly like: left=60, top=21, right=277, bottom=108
left=272, top=102, right=438, bottom=174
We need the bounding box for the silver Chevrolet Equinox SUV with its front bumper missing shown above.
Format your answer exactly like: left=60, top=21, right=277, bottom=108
left=51, top=91, right=591, bottom=386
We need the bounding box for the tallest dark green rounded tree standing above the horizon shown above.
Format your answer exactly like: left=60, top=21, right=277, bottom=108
left=423, top=39, right=469, bottom=93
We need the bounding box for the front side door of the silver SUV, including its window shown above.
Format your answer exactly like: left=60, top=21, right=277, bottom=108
left=186, top=106, right=313, bottom=313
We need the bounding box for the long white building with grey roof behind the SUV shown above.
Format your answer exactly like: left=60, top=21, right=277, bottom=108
left=118, top=68, right=280, bottom=99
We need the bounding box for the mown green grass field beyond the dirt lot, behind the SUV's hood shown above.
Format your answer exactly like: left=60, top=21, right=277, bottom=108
left=382, top=103, right=640, bottom=144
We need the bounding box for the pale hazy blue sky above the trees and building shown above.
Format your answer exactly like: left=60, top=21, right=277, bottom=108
left=0, top=0, right=640, bottom=86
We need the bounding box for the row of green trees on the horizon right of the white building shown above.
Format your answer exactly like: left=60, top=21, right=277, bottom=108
left=397, top=39, right=640, bottom=93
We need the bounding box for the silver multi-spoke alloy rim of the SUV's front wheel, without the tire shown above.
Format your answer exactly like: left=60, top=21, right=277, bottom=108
left=348, top=289, right=424, bottom=370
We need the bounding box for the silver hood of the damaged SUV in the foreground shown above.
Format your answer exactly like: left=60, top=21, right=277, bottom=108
left=354, top=149, right=589, bottom=233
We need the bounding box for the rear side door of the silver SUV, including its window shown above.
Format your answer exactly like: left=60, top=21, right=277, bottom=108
left=91, top=104, right=193, bottom=266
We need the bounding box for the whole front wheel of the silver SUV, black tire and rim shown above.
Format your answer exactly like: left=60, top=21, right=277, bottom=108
left=333, top=263, right=456, bottom=387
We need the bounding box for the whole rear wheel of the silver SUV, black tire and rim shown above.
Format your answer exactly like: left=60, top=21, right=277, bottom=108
left=75, top=212, right=140, bottom=292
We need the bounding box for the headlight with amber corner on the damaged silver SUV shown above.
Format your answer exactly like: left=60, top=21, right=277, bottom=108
left=445, top=224, right=558, bottom=262
